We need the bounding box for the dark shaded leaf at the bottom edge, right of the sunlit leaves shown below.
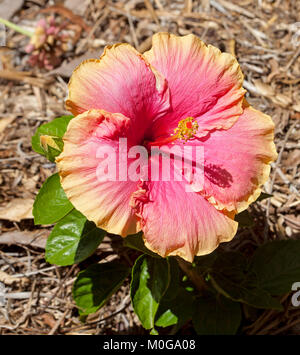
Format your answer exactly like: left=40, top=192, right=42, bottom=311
left=193, top=295, right=242, bottom=335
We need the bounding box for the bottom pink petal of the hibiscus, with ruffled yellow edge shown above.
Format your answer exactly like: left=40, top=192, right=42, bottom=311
left=131, top=177, right=237, bottom=262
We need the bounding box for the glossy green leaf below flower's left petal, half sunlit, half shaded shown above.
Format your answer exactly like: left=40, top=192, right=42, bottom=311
left=46, top=209, right=106, bottom=266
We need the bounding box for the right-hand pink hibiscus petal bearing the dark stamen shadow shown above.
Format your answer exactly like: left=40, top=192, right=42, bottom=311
left=202, top=101, right=277, bottom=212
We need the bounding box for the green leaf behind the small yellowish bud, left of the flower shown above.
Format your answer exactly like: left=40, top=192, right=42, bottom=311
left=31, top=116, right=74, bottom=162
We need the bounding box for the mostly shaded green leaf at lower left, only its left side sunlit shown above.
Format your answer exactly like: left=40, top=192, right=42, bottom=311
left=73, top=261, right=130, bottom=315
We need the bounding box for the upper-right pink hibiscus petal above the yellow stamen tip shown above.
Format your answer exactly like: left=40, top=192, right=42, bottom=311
left=144, top=33, right=245, bottom=137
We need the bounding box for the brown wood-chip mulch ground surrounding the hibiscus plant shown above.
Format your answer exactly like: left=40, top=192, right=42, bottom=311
left=0, top=0, right=300, bottom=334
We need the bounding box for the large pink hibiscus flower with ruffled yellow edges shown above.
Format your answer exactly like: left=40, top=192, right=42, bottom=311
left=57, top=33, right=276, bottom=261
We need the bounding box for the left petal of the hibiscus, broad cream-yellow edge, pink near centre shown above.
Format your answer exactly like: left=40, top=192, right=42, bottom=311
left=56, top=110, right=140, bottom=236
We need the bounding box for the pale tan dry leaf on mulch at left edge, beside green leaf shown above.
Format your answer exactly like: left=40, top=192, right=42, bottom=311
left=0, top=198, right=34, bottom=222
